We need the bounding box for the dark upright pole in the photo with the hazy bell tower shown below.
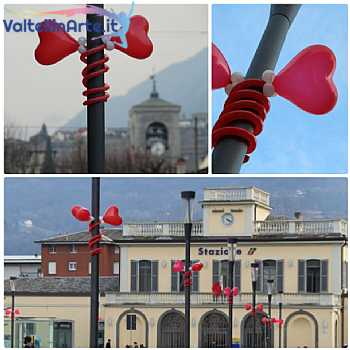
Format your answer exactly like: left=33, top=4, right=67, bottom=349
left=86, top=4, right=105, bottom=174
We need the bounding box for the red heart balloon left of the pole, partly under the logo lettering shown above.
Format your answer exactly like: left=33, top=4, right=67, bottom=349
left=35, top=20, right=79, bottom=65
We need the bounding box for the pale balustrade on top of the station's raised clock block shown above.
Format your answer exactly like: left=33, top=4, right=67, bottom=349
left=204, top=187, right=270, bottom=205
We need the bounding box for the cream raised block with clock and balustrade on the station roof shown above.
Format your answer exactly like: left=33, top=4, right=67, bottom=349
left=202, top=187, right=271, bottom=236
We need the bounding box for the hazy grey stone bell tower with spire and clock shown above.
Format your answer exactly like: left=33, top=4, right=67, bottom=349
left=129, top=75, right=181, bottom=163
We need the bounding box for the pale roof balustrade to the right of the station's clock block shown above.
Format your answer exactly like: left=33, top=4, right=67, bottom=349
left=255, top=220, right=347, bottom=235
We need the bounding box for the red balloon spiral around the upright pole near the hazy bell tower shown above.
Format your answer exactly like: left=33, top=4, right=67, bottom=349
left=80, top=44, right=109, bottom=106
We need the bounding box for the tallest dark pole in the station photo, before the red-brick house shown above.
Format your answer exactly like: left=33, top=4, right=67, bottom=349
left=90, top=177, right=100, bottom=348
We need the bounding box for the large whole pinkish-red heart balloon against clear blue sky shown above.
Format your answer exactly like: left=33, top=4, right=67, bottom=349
left=273, top=45, right=338, bottom=114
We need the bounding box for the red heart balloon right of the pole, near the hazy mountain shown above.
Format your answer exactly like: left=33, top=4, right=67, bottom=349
left=111, top=16, right=153, bottom=60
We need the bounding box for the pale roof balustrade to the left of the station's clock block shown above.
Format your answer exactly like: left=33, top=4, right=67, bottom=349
left=123, top=222, right=203, bottom=237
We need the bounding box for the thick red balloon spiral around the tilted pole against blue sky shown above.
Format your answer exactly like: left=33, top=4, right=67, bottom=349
left=212, top=79, right=270, bottom=162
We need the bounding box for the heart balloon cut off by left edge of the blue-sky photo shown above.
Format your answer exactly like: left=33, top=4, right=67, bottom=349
left=211, top=43, right=231, bottom=89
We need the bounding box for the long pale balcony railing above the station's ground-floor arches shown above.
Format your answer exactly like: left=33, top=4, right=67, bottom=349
left=106, top=292, right=340, bottom=306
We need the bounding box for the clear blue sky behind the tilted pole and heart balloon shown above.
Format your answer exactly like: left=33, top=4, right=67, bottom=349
left=212, top=5, right=348, bottom=173
